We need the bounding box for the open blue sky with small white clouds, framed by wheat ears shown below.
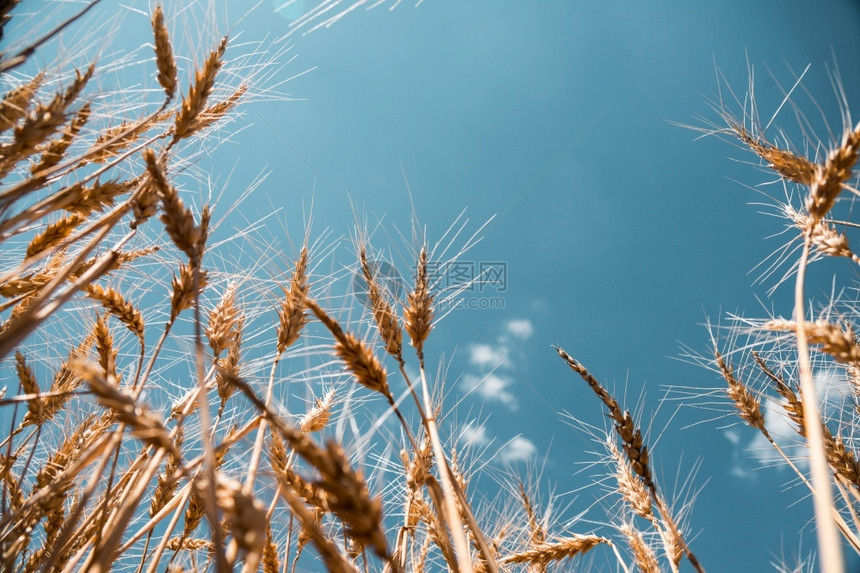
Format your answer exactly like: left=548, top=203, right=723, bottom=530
left=8, top=0, right=860, bottom=571
